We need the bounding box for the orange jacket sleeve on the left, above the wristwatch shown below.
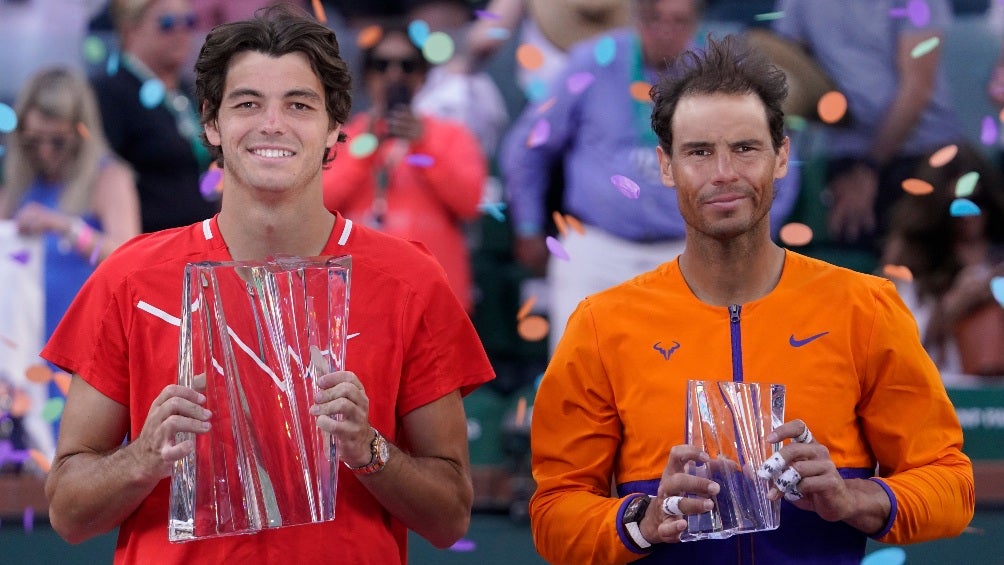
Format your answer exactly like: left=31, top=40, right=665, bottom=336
left=530, top=302, right=642, bottom=563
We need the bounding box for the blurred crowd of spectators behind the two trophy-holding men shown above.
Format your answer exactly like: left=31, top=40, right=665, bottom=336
left=0, top=0, right=1004, bottom=487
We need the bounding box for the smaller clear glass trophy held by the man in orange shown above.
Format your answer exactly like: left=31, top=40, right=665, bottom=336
left=680, top=380, right=784, bottom=542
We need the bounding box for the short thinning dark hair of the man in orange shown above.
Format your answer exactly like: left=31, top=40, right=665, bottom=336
left=651, top=35, right=788, bottom=155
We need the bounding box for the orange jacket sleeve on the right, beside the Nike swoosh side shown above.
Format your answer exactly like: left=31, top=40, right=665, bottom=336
left=858, top=281, right=975, bottom=544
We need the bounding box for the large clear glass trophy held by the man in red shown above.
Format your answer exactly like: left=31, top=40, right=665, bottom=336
left=168, top=256, right=351, bottom=542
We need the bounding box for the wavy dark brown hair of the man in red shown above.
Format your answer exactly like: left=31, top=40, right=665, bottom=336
left=195, top=4, right=352, bottom=167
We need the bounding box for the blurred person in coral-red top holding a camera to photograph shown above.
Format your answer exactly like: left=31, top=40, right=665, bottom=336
left=323, top=26, right=488, bottom=313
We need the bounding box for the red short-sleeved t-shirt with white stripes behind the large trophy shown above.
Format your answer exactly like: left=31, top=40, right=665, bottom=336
left=42, top=216, right=494, bottom=565
